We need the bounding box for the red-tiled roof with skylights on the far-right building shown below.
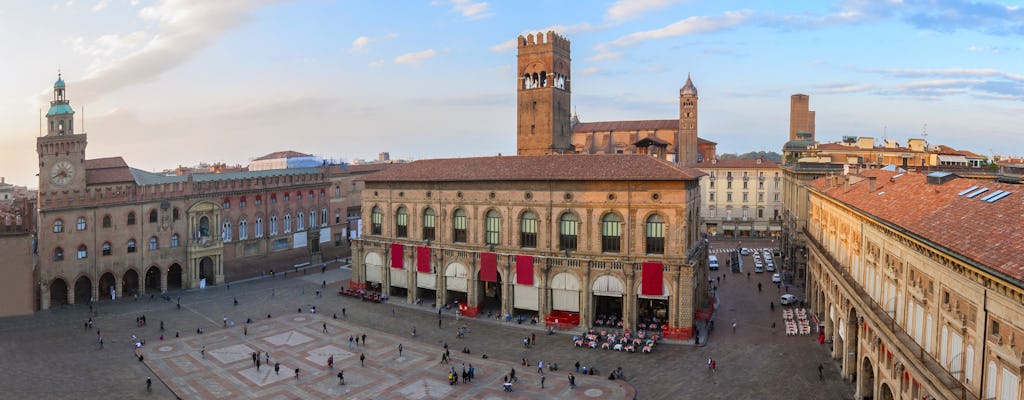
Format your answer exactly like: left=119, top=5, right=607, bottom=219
left=811, top=170, right=1024, bottom=280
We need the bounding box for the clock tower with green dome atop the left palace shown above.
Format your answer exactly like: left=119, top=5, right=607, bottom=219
left=36, top=74, right=86, bottom=193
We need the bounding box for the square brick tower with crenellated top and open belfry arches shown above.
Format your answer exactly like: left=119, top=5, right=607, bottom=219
left=516, top=31, right=572, bottom=155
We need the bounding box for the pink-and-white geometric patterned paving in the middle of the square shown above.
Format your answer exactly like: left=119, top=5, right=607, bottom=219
left=139, top=314, right=635, bottom=400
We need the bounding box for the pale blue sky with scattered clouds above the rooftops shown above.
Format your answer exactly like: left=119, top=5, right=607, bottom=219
left=0, top=0, right=1024, bottom=187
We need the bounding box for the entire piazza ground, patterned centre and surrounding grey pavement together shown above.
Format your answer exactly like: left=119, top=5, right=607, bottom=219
left=0, top=240, right=853, bottom=400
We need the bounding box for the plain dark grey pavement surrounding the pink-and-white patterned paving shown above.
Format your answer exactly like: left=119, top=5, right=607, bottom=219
left=0, top=241, right=853, bottom=399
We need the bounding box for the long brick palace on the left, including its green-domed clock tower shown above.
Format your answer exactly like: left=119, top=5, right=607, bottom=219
left=36, top=79, right=360, bottom=309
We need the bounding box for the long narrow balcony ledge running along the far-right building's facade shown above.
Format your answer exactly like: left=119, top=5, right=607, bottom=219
left=803, top=227, right=970, bottom=400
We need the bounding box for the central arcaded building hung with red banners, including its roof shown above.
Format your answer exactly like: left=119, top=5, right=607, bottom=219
left=351, top=154, right=709, bottom=338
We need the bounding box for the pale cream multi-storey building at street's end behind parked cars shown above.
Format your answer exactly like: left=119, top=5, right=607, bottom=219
left=695, top=159, right=782, bottom=237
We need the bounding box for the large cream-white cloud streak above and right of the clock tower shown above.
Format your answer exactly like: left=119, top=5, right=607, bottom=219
left=40, top=0, right=279, bottom=105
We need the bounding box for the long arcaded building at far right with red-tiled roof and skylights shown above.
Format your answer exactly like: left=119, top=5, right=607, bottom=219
left=805, top=170, right=1024, bottom=399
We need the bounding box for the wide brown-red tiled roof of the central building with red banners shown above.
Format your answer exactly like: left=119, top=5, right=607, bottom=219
left=365, top=154, right=703, bottom=182
